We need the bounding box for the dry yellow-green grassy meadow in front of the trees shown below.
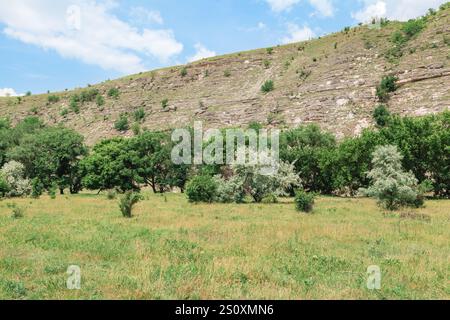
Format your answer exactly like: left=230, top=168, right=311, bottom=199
left=0, top=194, right=450, bottom=299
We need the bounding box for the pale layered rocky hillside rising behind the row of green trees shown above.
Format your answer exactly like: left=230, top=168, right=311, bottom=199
left=0, top=9, right=450, bottom=144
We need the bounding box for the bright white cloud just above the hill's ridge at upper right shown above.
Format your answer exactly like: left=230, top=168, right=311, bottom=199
left=352, top=0, right=447, bottom=22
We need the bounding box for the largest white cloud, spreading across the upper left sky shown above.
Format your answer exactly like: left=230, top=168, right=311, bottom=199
left=0, top=0, right=183, bottom=74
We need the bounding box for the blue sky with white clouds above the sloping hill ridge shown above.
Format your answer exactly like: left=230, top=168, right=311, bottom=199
left=0, top=0, right=447, bottom=96
